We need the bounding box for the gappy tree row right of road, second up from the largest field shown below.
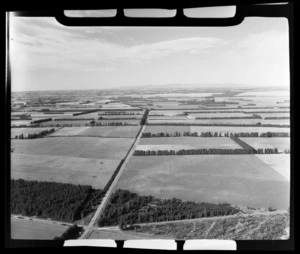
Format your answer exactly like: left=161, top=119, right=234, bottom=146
left=141, top=131, right=290, bottom=138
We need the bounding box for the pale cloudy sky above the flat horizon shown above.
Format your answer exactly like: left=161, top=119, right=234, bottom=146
left=9, top=11, right=289, bottom=91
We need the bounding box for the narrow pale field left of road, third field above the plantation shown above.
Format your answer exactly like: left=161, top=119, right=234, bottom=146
left=50, top=126, right=140, bottom=138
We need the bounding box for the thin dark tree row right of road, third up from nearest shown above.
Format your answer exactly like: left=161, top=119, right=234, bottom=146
left=147, top=122, right=290, bottom=128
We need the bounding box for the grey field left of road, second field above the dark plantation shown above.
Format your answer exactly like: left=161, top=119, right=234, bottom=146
left=11, top=137, right=134, bottom=159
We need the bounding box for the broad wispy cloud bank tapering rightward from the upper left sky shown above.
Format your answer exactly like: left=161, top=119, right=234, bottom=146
left=11, top=18, right=226, bottom=71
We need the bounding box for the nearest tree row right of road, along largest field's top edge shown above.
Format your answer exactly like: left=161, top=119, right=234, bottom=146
left=133, top=148, right=278, bottom=156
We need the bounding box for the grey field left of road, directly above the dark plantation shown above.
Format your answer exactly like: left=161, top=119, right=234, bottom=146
left=11, top=153, right=120, bottom=189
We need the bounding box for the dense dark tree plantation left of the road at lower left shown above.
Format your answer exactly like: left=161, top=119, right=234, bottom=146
left=11, top=179, right=103, bottom=222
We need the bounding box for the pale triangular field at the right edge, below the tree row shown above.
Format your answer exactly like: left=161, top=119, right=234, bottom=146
left=255, top=154, right=291, bottom=181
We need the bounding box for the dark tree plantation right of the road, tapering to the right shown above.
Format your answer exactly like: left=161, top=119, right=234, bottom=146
left=98, top=189, right=239, bottom=229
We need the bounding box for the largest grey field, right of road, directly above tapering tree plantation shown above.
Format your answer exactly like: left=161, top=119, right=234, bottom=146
left=116, top=155, right=289, bottom=210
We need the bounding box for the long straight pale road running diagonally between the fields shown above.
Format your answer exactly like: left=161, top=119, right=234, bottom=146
left=79, top=125, right=146, bottom=239
